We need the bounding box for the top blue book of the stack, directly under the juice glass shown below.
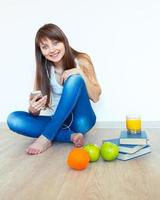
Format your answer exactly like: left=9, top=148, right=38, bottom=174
left=119, top=130, right=149, bottom=145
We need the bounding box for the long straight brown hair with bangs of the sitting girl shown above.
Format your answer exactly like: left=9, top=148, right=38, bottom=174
left=35, top=24, right=83, bottom=107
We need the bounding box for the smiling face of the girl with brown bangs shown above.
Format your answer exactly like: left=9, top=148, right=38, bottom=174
left=39, top=38, right=65, bottom=67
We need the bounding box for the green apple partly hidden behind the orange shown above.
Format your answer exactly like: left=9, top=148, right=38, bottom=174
left=83, top=144, right=100, bottom=162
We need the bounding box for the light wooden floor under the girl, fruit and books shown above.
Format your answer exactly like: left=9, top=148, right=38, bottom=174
left=0, top=129, right=160, bottom=200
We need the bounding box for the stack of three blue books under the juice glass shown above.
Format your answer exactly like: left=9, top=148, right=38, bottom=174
left=103, top=130, right=151, bottom=160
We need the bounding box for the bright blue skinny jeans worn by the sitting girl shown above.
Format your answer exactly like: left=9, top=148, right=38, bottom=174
left=7, top=75, right=96, bottom=142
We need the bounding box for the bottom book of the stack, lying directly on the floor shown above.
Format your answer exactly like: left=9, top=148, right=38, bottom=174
left=117, top=145, right=151, bottom=161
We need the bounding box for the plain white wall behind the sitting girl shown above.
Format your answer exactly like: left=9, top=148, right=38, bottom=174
left=0, top=0, right=160, bottom=121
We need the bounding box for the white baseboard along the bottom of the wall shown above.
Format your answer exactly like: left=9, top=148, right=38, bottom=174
left=0, top=121, right=160, bottom=129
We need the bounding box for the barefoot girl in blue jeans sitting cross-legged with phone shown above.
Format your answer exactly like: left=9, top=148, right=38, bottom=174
left=7, top=24, right=101, bottom=155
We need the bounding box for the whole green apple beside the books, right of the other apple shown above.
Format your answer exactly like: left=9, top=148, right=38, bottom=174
left=100, top=142, right=119, bottom=161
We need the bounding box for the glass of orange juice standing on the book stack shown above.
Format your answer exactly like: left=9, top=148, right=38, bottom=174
left=126, top=115, right=141, bottom=134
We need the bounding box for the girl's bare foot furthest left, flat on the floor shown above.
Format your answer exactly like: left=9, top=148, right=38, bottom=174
left=26, top=135, right=52, bottom=155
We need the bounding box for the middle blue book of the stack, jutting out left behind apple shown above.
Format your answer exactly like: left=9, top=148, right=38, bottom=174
left=103, top=138, right=146, bottom=154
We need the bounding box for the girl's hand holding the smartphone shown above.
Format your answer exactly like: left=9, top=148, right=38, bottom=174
left=28, top=94, right=47, bottom=115
